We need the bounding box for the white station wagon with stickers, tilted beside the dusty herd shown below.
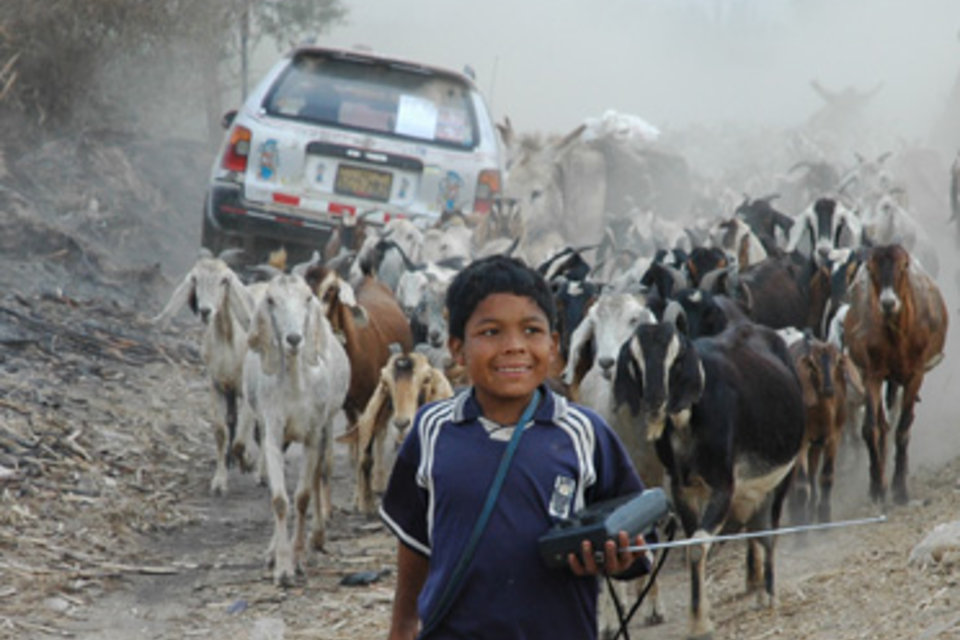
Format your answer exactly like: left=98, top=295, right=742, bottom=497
left=202, top=46, right=502, bottom=260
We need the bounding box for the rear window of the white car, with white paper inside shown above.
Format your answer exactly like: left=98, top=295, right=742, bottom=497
left=264, top=54, right=477, bottom=149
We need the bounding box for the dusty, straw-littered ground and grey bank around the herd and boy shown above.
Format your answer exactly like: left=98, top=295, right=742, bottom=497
left=0, top=125, right=960, bottom=640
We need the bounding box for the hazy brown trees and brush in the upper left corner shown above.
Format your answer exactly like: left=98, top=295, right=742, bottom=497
left=0, top=0, right=346, bottom=139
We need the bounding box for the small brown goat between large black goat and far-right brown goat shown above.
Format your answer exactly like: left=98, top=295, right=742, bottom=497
left=790, top=335, right=863, bottom=523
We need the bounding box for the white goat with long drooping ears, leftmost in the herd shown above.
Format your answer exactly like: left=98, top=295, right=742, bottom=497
left=152, top=250, right=253, bottom=494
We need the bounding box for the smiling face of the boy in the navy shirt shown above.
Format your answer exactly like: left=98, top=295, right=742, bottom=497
left=449, top=293, right=559, bottom=423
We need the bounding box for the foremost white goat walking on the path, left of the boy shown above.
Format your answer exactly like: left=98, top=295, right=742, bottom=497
left=240, top=274, right=350, bottom=586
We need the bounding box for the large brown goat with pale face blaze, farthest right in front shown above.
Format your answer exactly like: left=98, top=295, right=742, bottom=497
left=844, top=245, right=947, bottom=504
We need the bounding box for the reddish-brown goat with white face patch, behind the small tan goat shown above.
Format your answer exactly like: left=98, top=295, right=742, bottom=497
left=304, top=265, right=413, bottom=430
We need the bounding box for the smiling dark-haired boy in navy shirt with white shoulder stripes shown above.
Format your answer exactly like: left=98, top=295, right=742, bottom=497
left=380, top=256, right=645, bottom=640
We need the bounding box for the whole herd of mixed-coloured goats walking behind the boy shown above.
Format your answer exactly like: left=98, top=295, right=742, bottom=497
left=154, top=182, right=947, bottom=637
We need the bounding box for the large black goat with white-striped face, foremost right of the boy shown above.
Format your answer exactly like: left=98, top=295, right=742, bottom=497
left=614, top=322, right=805, bottom=638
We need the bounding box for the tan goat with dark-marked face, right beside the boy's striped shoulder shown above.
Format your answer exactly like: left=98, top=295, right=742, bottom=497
left=342, top=353, right=453, bottom=513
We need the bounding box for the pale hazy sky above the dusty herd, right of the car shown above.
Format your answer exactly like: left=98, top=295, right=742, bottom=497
left=304, top=0, right=960, bottom=137
